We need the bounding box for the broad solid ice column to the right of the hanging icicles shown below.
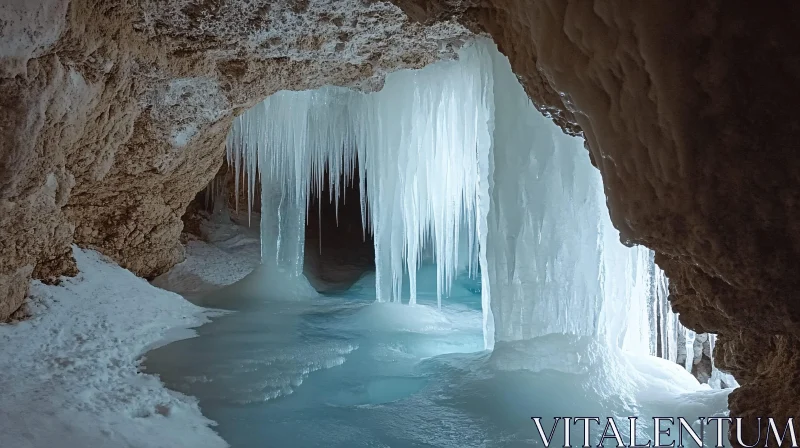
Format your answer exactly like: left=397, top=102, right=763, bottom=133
left=485, top=42, right=654, bottom=353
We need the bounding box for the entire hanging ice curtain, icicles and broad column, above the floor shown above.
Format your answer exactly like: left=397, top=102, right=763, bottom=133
left=228, top=36, right=736, bottom=384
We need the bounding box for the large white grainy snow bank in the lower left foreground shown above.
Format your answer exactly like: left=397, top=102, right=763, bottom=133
left=0, top=247, right=227, bottom=448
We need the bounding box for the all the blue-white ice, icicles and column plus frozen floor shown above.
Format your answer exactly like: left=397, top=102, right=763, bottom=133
left=145, top=39, right=736, bottom=447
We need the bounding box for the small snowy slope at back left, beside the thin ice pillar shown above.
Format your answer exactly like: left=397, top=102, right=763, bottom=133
left=153, top=213, right=261, bottom=297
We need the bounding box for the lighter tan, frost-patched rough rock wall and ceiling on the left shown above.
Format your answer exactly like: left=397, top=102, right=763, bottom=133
left=0, top=0, right=470, bottom=320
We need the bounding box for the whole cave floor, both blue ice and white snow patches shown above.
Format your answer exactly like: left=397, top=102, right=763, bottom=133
left=0, top=229, right=728, bottom=448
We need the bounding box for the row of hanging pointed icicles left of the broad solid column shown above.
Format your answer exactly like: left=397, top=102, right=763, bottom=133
left=228, top=41, right=491, bottom=304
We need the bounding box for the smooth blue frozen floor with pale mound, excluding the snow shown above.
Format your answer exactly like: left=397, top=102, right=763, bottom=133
left=145, top=262, right=728, bottom=448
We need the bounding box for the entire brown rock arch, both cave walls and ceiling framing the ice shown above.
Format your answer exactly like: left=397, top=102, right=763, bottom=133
left=0, top=0, right=800, bottom=440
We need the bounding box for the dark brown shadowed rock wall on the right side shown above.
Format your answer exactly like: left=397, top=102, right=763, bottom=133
left=397, top=0, right=800, bottom=443
